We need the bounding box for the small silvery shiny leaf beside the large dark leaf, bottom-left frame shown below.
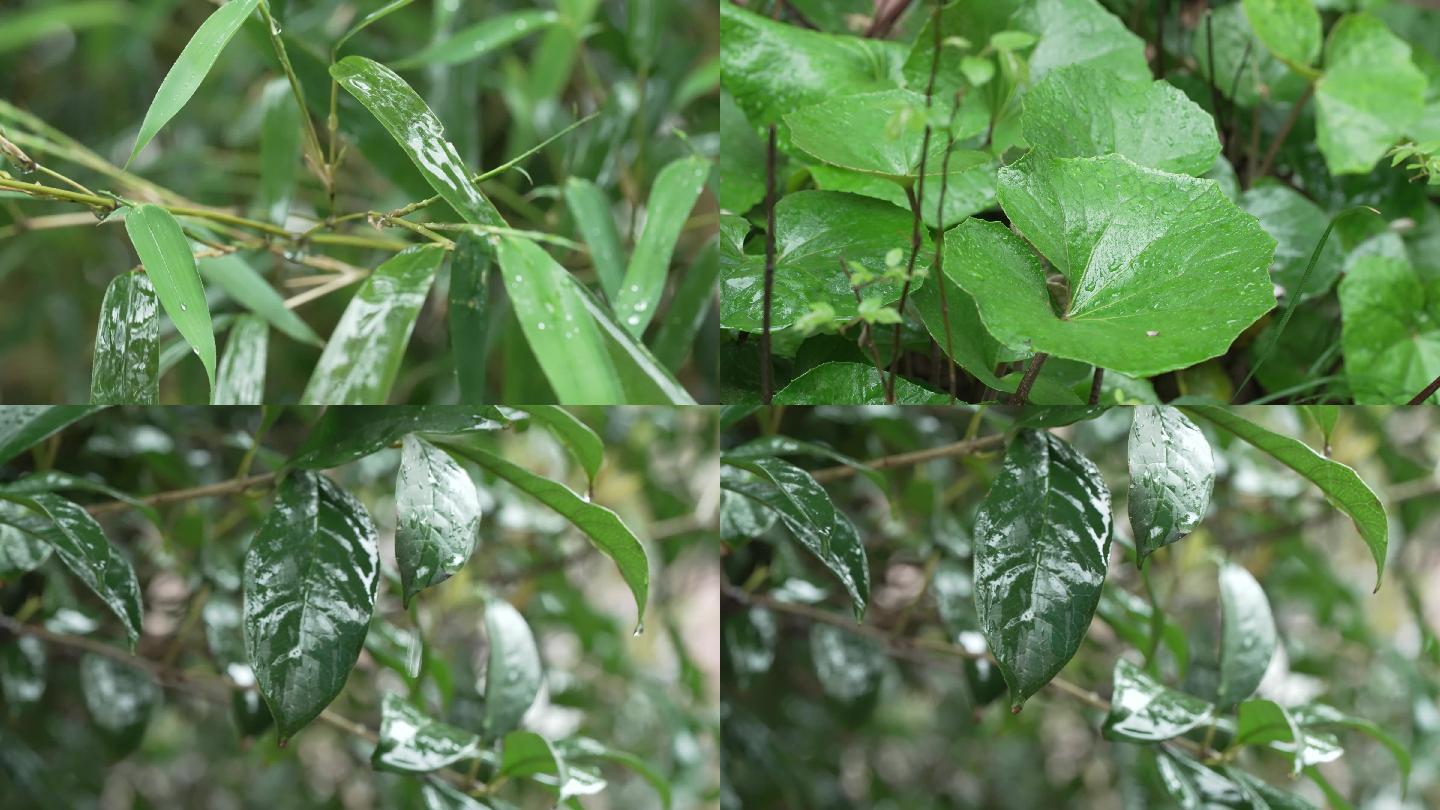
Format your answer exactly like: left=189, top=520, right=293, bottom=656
left=395, top=435, right=480, bottom=607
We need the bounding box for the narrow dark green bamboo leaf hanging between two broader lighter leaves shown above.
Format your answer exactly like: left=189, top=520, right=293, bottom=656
left=448, top=231, right=495, bottom=402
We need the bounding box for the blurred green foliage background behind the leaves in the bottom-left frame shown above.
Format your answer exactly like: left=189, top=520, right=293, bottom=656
left=0, top=408, right=720, bottom=810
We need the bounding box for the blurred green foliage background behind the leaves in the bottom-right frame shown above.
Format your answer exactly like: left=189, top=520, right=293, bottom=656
left=721, top=406, right=1440, bottom=810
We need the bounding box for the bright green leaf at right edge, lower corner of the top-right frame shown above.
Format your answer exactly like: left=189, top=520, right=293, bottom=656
left=1339, top=255, right=1440, bottom=405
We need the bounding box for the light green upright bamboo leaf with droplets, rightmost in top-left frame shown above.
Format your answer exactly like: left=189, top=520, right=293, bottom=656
left=613, top=157, right=710, bottom=336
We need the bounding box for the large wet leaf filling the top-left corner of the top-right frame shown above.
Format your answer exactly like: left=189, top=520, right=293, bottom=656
left=720, top=3, right=906, bottom=134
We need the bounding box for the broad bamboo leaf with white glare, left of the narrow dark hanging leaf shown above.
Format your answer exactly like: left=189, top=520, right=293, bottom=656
left=300, top=245, right=445, bottom=405
